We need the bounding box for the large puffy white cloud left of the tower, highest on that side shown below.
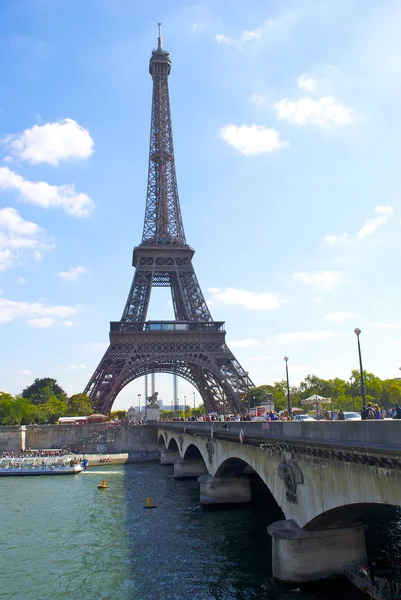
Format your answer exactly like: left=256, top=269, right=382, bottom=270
left=3, top=119, right=94, bottom=166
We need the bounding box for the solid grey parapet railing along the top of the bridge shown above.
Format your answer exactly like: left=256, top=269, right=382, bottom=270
left=155, top=420, right=401, bottom=456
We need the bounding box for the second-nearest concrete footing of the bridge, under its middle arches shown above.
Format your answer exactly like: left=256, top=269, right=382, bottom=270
left=198, top=475, right=252, bottom=504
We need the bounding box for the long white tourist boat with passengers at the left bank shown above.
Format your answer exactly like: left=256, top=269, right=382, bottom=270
left=0, top=454, right=82, bottom=477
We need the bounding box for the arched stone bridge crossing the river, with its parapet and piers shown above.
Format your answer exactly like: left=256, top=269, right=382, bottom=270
left=157, top=420, right=401, bottom=583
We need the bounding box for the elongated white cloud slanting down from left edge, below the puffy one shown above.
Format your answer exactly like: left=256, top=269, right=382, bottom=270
left=0, top=167, right=95, bottom=217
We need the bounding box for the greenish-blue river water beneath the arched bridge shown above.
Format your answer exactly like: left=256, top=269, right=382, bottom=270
left=0, top=463, right=388, bottom=600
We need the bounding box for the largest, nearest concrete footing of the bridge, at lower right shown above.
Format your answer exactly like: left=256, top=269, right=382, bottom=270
left=267, top=519, right=367, bottom=584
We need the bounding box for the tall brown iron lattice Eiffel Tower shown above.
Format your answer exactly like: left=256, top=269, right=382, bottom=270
left=85, top=24, right=253, bottom=414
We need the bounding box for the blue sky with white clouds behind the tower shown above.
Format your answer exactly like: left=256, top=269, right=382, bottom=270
left=0, top=0, right=401, bottom=408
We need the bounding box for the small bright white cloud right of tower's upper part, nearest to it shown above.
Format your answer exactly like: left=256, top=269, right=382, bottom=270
left=220, top=125, right=288, bottom=154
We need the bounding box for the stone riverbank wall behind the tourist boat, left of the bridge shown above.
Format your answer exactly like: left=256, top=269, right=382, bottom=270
left=0, top=423, right=158, bottom=459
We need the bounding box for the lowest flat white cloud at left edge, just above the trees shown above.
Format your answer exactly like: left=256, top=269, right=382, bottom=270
left=0, top=297, right=79, bottom=327
